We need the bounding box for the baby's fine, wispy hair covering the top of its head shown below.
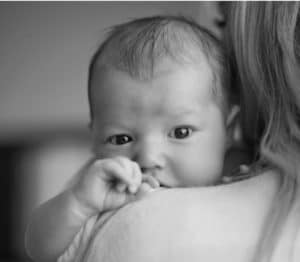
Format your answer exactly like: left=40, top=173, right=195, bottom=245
left=88, top=16, right=230, bottom=119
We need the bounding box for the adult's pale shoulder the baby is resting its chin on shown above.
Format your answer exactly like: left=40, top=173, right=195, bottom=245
left=87, top=172, right=279, bottom=262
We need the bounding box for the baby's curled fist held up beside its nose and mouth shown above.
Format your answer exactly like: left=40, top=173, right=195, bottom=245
left=71, top=157, right=142, bottom=216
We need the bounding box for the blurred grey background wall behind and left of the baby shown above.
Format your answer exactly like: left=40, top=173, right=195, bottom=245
left=0, top=2, right=221, bottom=261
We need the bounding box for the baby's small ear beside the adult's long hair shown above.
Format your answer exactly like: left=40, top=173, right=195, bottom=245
left=226, top=105, right=242, bottom=147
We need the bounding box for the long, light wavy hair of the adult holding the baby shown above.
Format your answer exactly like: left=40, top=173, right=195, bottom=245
left=225, top=1, right=300, bottom=261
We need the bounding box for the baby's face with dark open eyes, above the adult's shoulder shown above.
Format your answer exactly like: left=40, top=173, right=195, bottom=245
left=91, top=61, right=226, bottom=187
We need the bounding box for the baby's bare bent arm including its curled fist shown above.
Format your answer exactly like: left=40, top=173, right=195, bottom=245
left=26, top=157, right=142, bottom=261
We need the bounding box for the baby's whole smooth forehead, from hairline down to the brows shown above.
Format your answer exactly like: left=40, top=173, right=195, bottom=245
left=91, top=63, right=230, bottom=127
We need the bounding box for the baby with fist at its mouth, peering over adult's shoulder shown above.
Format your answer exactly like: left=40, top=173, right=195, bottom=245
left=26, top=16, right=238, bottom=261
